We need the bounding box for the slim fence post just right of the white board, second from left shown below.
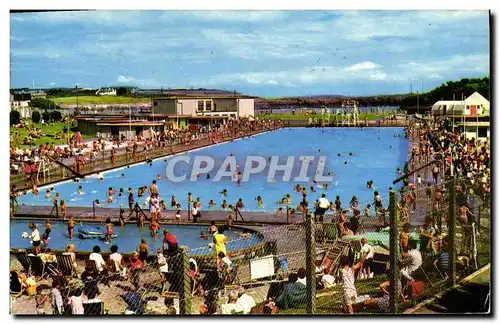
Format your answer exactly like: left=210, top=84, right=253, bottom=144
left=305, top=214, right=316, bottom=314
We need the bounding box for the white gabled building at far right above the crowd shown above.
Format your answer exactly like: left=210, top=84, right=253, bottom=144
left=431, top=92, right=490, bottom=139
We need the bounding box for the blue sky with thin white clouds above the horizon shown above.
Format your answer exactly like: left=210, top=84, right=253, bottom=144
left=10, top=11, right=489, bottom=97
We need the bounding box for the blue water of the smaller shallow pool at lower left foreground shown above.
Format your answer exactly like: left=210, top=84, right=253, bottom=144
left=10, top=220, right=261, bottom=254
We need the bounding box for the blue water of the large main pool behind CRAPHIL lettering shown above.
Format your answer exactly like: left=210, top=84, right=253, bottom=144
left=19, top=127, right=408, bottom=212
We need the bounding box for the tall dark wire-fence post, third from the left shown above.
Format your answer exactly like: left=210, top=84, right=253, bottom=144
left=389, top=190, right=400, bottom=314
